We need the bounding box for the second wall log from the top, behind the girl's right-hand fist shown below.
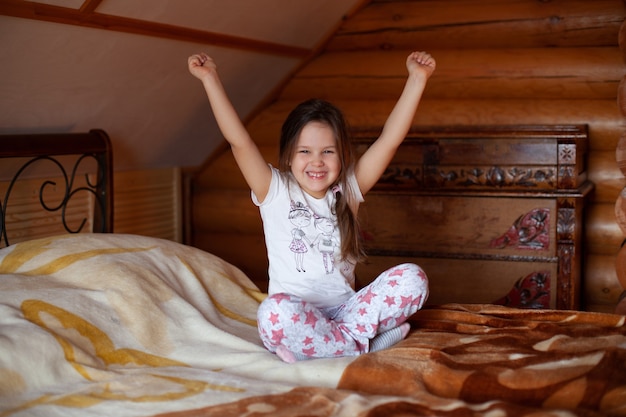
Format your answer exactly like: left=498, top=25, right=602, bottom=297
left=281, top=47, right=626, bottom=100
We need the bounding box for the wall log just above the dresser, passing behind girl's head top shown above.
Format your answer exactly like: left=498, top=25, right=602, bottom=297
left=239, top=97, right=626, bottom=155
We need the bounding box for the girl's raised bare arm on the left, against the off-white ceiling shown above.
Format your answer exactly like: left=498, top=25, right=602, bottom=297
left=187, top=53, right=272, bottom=201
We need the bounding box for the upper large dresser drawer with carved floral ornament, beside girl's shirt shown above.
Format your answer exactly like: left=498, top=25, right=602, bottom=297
left=361, top=192, right=557, bottom=258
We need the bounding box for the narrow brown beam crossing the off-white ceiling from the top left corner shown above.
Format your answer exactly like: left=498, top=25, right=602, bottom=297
left=0, top=0, right=312, bottom=58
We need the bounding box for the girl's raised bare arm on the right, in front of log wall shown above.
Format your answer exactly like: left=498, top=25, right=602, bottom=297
left=355, top=52, right=436, bottom=195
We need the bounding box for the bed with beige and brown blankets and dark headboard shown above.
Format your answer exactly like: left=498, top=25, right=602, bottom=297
left=0, top=132, right=626, bottom=417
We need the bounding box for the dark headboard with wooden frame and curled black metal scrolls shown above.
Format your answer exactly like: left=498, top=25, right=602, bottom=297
left=0, top=129, right=113, bottom=247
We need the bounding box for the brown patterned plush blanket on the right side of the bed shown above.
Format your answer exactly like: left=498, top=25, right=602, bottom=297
left=155, top=305, right=626, bottom=417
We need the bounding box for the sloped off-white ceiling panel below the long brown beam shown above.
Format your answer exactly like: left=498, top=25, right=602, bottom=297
left=0, top=16, right=298, bottom=170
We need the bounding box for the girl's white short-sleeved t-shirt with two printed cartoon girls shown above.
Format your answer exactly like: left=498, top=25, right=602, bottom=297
left=252, top=167, right=363, bottom=308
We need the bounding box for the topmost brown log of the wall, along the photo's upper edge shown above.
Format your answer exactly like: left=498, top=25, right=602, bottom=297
left=327, top=0, right=626, bottom=51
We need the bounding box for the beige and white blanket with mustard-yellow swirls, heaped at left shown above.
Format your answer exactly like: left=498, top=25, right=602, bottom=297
left=0, top=235, right=350, bottom=417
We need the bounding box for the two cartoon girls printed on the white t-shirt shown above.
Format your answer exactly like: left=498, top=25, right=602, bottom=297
left=288, top=200, right=340, bottom=274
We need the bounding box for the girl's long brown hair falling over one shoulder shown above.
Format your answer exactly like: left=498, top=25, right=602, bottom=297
left=278, top=99, right=365, bottom=262
